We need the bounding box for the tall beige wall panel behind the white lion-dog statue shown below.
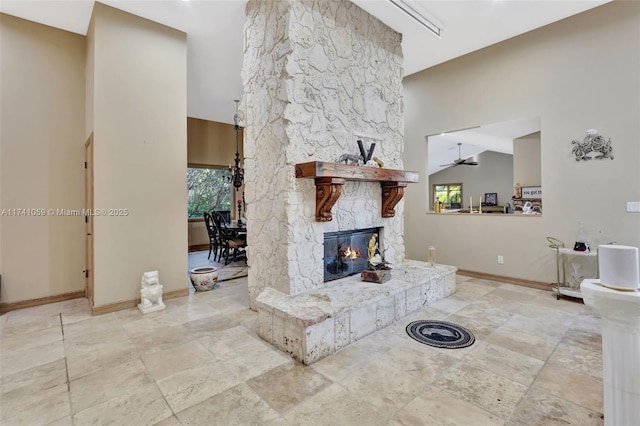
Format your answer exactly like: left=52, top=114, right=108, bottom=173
left=87, top=3, right=187, bottom=307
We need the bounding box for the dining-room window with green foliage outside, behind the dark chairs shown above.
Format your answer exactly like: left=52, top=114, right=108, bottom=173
left=187, top=167, right=232, bottom=219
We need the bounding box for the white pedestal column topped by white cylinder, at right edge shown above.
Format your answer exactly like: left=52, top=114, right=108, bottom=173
left=580, top=245, right=640, bottom=426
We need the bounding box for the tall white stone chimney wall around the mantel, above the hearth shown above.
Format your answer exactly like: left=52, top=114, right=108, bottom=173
left=242, top=0, right=405, bottom=309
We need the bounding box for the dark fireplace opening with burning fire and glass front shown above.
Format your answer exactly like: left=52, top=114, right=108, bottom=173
left=324, top=228, right=381, bottom=282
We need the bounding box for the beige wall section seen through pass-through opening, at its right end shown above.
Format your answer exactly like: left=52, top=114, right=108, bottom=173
left=513, top=132, right=542, bottom=186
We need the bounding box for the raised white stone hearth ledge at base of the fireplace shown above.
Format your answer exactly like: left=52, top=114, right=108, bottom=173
left=257, top=260, right=456, bottom=365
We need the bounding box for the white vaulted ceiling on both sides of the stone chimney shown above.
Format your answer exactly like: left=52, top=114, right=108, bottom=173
left=0, top=0, right=610, bottom=123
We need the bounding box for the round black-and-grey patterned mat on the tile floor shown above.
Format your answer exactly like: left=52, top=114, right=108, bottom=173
left=407, top=320, right=476, bottom=349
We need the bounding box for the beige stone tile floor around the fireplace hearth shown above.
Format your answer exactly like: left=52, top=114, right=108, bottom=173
left=0, top=276, right=603, bottom=426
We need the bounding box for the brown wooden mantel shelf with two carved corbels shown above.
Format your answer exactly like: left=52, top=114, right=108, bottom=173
left=296, top=161, right=419, bottom=222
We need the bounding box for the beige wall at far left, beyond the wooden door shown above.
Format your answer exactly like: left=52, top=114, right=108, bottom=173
left=0, top=14, right=86, bottom=302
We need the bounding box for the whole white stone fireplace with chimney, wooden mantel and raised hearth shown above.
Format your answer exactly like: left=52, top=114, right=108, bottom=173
left=241, top=0, right=455, bottom=364
